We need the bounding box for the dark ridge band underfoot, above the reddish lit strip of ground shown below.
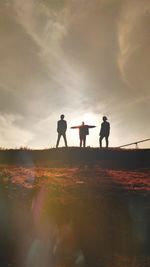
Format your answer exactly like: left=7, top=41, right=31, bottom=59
left=0, top=147, right=150, bottom=169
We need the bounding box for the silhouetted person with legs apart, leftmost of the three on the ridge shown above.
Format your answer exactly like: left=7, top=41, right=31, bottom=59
left=56, top=115, right=67, bottom=147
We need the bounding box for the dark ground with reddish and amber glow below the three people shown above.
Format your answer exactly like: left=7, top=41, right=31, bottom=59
left=0, top=148, right=150, bottom=267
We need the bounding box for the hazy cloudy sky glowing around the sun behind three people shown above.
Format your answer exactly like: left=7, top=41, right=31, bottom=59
left=0, top=0, right=150, bottom=148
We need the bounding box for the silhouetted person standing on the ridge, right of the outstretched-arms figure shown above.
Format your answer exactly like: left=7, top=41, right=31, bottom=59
left=99, top=116, right=110, bottom=147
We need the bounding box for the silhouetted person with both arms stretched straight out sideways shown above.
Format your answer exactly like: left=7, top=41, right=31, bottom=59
left=71, top=122, right=96, bottom=147
